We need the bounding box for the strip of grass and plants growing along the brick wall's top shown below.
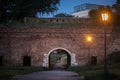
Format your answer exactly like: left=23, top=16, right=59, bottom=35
left=0, top=18, right=99, bottom=28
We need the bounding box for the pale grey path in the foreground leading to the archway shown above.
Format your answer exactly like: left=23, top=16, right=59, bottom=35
left=14, top=71, right=84, bottom=80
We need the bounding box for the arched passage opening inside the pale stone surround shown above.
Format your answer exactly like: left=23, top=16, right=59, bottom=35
left=49, top=49, right=71, bottom=69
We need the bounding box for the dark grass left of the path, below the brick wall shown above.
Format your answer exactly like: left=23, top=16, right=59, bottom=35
left=0, top=67, right=47, bottom=80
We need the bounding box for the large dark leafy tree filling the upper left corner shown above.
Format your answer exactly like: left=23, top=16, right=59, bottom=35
left=0, top=0, right=60, bottom=20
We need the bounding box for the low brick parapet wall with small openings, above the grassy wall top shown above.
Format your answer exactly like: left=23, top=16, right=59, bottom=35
left=24, top=17, right=90, bottom=23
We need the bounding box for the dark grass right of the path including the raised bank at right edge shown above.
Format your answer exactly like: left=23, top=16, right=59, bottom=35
left=67, top=51, right=120, bottom=80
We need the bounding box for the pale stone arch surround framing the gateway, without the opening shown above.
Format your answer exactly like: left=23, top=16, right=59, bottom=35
left=43, top=47, right=78, bottom=67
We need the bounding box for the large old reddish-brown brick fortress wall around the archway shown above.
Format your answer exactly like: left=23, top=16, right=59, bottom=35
left=0, top=28, right=120, bottom=67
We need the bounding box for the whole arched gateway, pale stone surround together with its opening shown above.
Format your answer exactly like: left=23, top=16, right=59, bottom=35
left=43, top=48, right=77, bottom=68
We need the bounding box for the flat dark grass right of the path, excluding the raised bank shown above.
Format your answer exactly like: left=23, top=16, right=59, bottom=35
left=67, top=64, right=120, bottom=80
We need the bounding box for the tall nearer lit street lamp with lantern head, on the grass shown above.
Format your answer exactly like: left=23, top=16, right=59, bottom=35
left=101, top=13, right=108, bottom=75
